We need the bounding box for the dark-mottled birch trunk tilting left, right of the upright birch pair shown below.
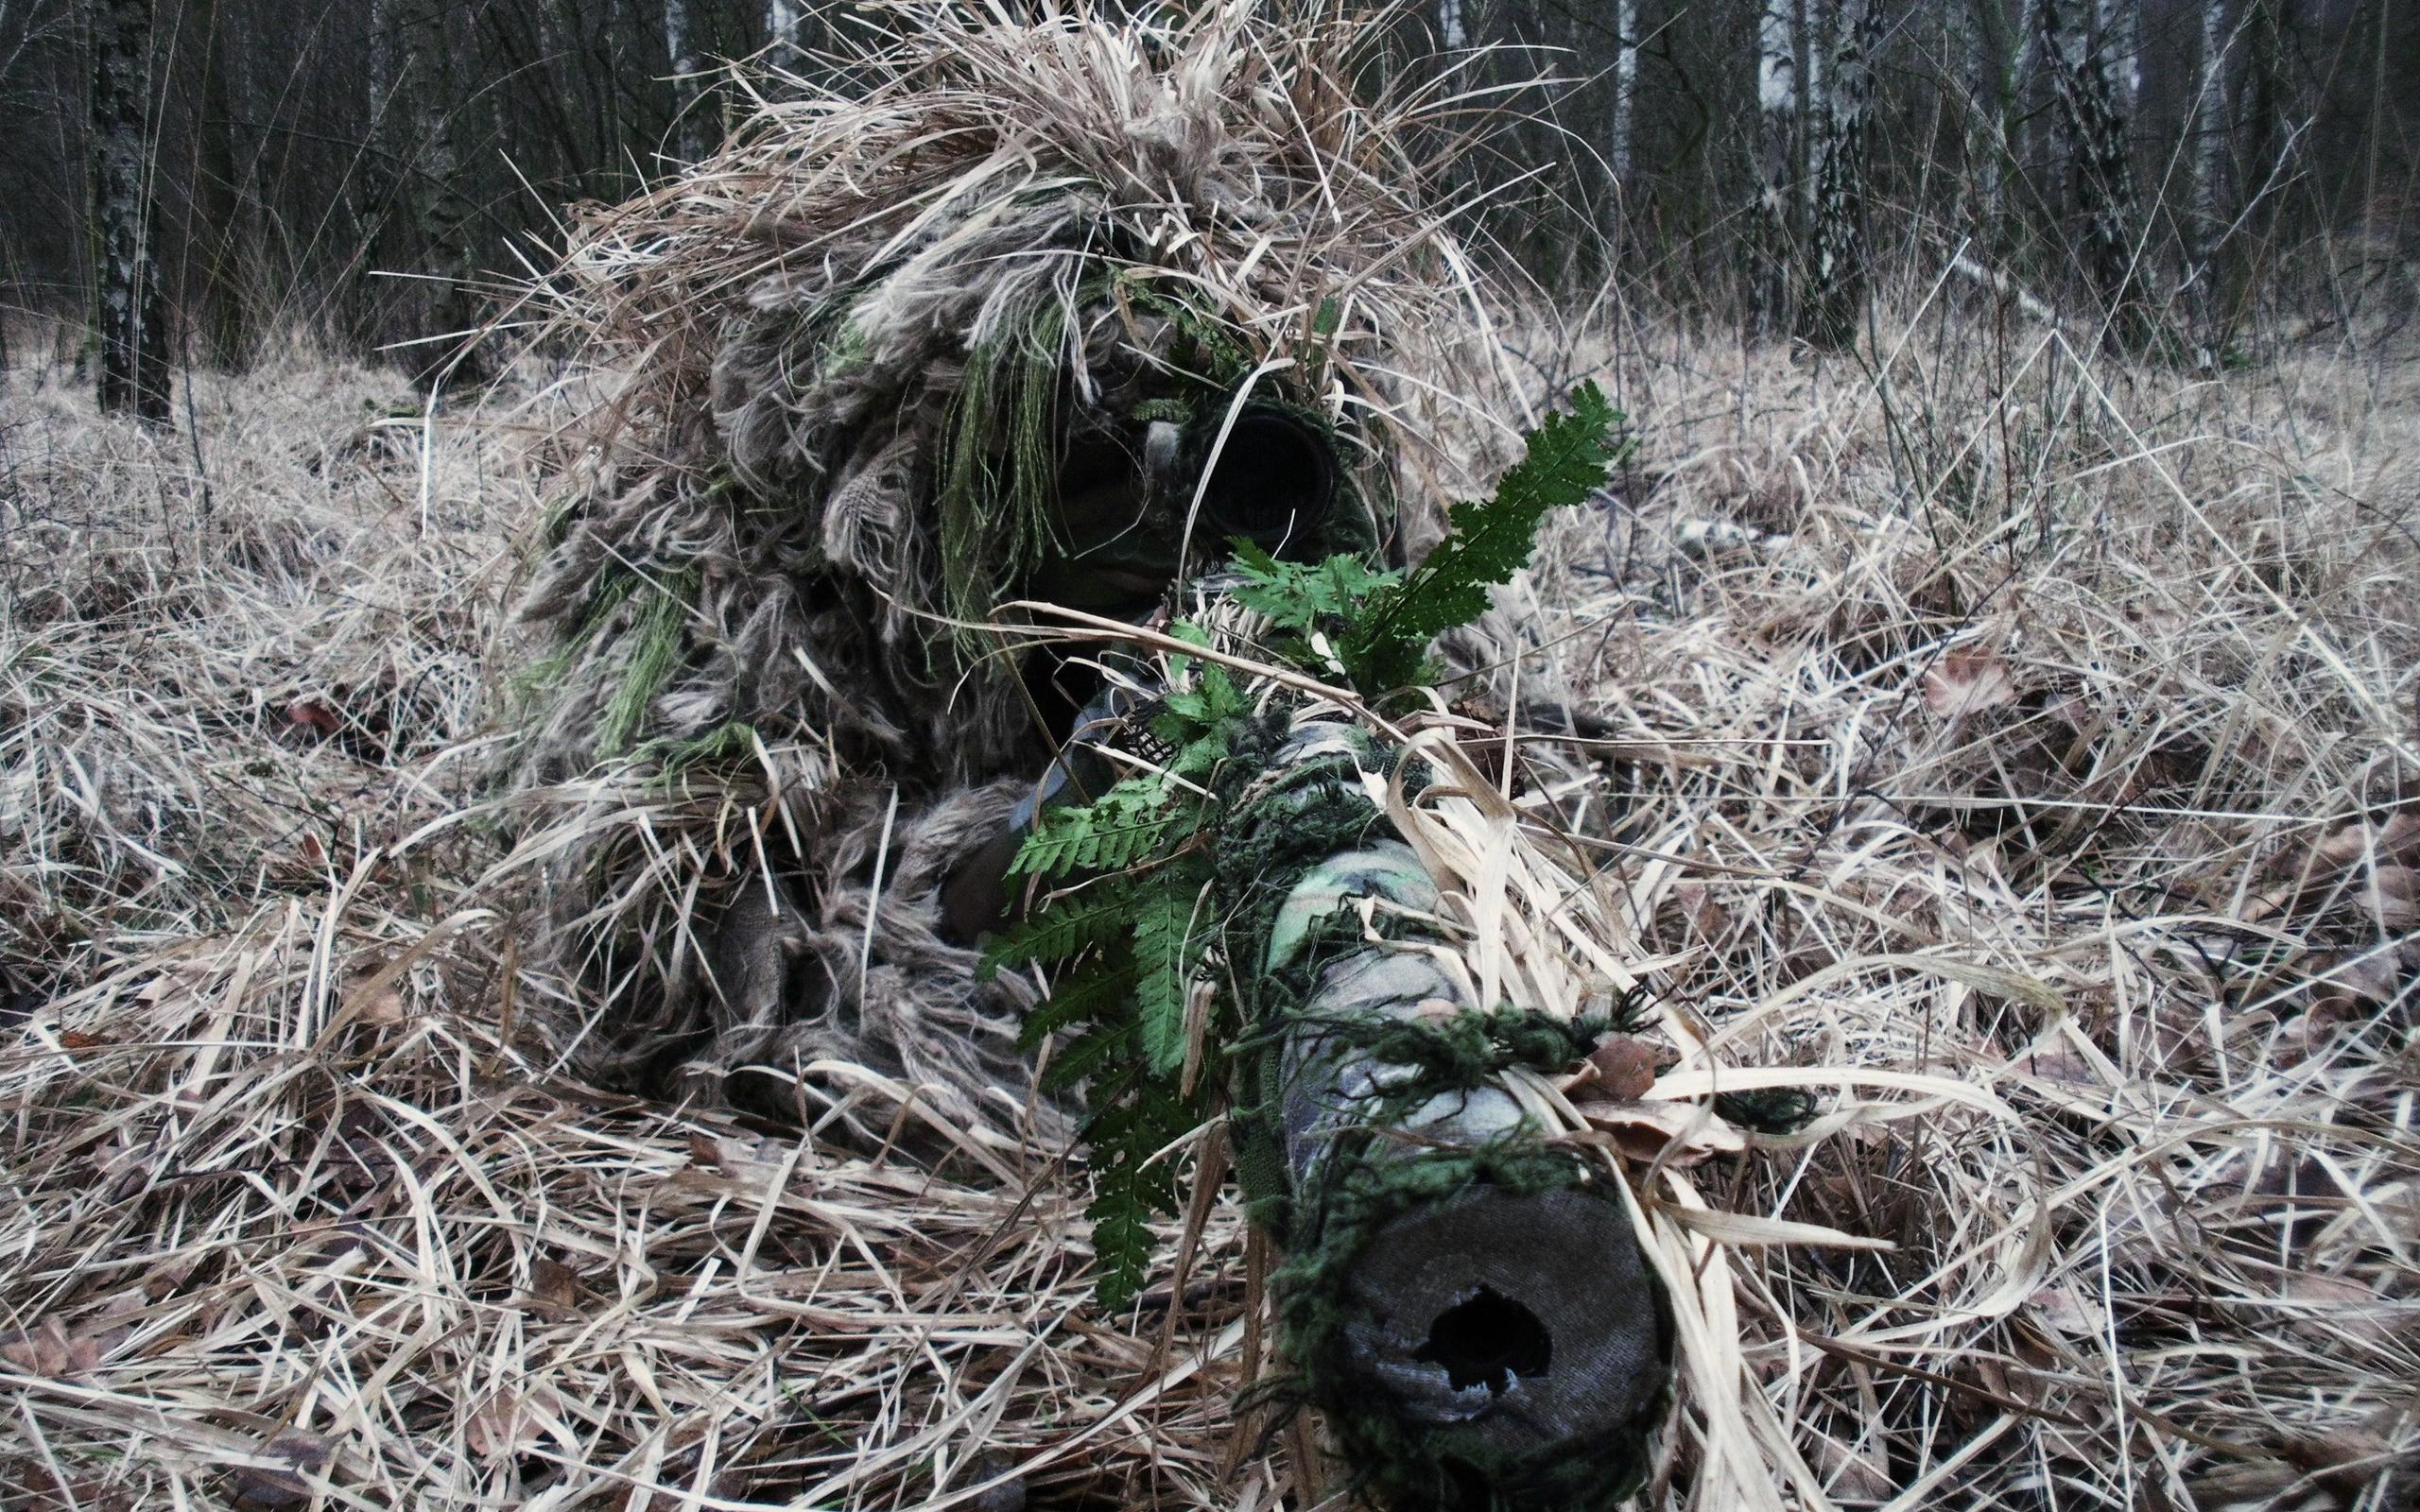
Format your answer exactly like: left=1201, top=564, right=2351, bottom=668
left=2040, top=0, right=2152, bottom=351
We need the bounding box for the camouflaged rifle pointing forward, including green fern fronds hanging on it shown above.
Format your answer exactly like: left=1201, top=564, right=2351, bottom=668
left=962, top=394, right=1672, bottom=1509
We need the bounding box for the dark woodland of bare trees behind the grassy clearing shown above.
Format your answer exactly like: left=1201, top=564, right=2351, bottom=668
left=0, top=0, right=2420, bottom=408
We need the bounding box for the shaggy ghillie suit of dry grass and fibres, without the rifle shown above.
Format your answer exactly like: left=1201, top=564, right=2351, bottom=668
left=503, top=5, right=1500, bottom=1118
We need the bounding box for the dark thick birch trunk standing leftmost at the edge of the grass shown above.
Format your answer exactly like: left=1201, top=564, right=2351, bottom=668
left=92, top=0, right=169, bottom=426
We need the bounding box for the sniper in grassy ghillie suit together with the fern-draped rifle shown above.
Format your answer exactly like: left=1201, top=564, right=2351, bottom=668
left=518, top=5, right=1800, bottom=1509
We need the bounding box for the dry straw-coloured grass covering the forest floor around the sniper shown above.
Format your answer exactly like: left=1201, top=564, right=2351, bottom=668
left=0, top=312, right=2420, bottom=1512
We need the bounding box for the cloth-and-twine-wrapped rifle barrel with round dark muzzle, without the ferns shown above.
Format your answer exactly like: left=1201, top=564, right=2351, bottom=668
left=1011, top=602, right=1672, bottom=1509
